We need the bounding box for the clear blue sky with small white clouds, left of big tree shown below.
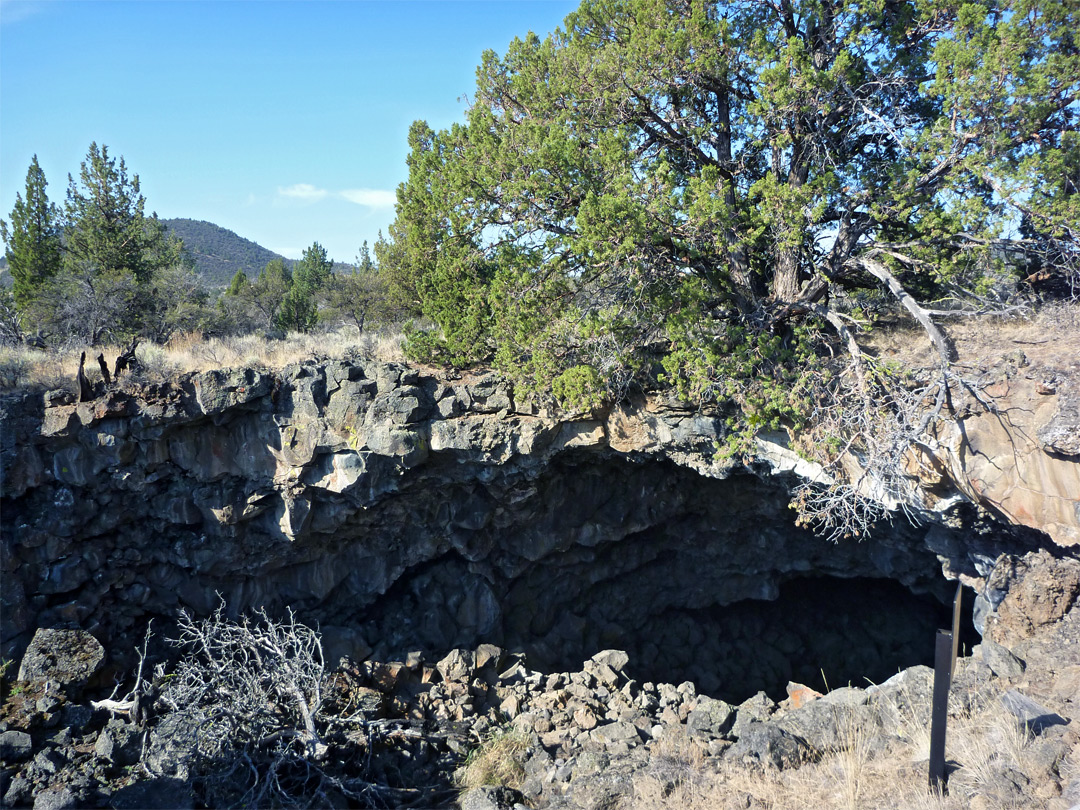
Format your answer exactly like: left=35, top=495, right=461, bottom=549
left=0, top=0, right=578, bottom=261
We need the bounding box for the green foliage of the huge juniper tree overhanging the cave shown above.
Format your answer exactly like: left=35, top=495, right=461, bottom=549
left=384, top=0, right=1080, bottom=419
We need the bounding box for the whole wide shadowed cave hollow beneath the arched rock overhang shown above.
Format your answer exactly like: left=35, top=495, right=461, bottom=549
left=349, top=456, right=977, bottom=702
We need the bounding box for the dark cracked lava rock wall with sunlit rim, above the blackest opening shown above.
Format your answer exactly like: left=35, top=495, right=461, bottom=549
left=2, top=361, right=1062, bottom=678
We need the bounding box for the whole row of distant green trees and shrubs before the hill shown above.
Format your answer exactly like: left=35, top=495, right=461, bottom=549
left=0, top=143, right=394, bottom=346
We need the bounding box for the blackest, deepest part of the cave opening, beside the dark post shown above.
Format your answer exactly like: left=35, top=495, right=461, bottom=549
left=525, top=577, right=978, bottom=703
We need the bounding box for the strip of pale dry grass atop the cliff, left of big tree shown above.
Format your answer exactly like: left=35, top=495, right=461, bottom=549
left=0, top=328, right=405, bottom=391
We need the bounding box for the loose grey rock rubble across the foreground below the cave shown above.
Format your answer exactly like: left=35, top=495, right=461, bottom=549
left=0, top=553, right=1080, bottom=810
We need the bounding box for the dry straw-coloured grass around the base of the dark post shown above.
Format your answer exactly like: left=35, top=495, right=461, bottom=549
left=621, top=701, right=1042, bottom=810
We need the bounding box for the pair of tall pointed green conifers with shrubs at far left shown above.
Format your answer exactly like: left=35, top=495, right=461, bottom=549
left=0, top=144, right=214, bottom=345
